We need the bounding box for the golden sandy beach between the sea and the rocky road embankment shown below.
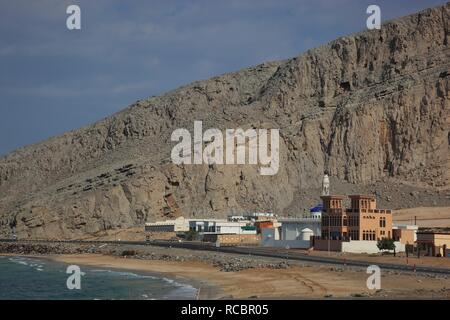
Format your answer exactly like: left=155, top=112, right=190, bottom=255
left=49, top=254, right=450, bottom=299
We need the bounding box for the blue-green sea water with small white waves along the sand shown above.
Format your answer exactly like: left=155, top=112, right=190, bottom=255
left=0, top=256, right=197, bottom=300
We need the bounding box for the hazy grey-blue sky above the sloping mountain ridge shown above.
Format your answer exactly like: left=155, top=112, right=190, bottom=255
left=0, top=0, right=446, bottom=155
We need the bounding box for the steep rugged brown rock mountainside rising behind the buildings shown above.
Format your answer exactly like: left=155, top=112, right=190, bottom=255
left=0, top=4, right=450, bottom=238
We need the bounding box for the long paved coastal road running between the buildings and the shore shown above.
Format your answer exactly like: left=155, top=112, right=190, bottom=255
left=0, top=239, right=450, bottom=275
